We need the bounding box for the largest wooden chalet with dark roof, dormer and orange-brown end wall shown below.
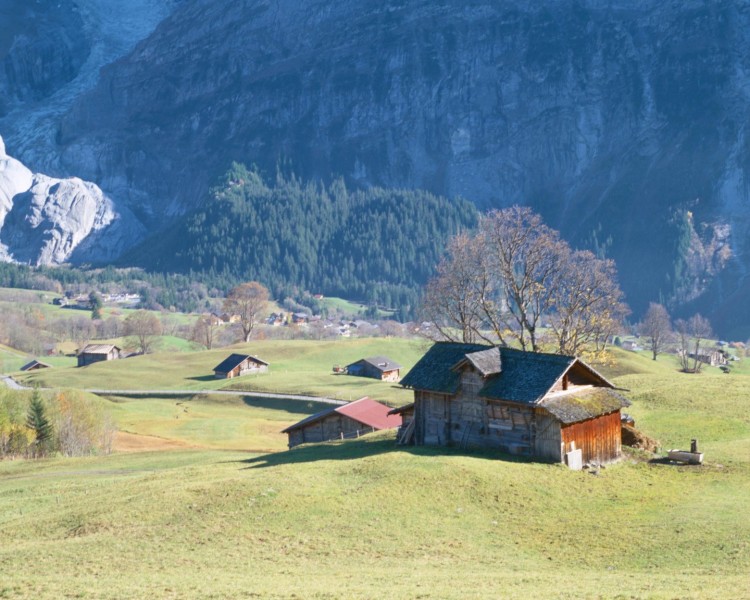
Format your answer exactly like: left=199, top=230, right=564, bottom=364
left=401, top=342, right=630, bottom=463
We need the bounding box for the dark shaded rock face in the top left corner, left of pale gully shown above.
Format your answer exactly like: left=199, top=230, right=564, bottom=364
left=0, top=0, right=91, bottom=116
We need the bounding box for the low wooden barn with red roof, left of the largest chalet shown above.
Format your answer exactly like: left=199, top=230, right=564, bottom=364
left=281, top=396, right=401, bottom=448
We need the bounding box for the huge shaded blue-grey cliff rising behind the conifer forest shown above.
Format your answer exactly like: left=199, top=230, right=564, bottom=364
left=59, top=0, right=750, bottom=328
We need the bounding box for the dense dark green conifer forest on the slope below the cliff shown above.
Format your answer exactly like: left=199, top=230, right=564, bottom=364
left=123, top=163, right=478, bottom=314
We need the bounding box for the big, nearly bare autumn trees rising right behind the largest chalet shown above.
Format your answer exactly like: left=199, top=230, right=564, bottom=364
left=422, top=206, right=629, bottom=355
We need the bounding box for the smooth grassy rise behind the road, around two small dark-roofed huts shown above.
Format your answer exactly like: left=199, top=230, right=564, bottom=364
left=17, top=338, right=427, bottom=403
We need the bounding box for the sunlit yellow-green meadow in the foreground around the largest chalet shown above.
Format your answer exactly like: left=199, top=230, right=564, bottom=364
left=0, top=340, right=750, bottom=599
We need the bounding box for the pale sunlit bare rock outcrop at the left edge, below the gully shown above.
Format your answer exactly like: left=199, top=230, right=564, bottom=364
left=0, top=138, right=143, bottom=265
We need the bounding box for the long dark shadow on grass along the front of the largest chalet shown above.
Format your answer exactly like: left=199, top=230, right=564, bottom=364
left=240, top=436, right=533, bottom=469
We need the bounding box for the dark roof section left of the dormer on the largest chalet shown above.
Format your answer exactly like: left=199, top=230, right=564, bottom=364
left=401, top=342, right=492, bottom=394
